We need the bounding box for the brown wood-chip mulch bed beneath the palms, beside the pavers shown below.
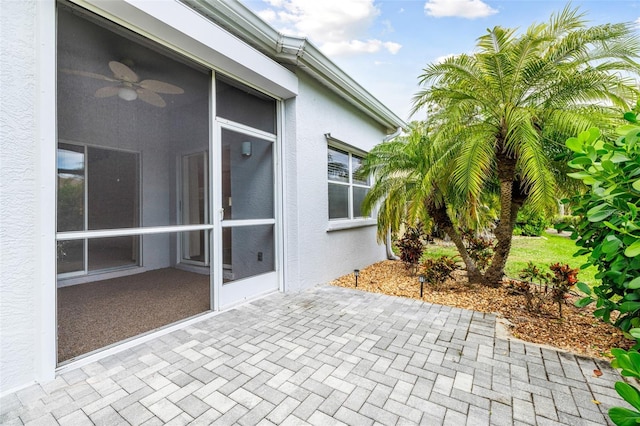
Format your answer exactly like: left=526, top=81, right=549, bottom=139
left=331, top=260, right=634, bottom=359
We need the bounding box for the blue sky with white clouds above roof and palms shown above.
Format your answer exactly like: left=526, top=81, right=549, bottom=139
left=241, top=0, right=640, bottom=120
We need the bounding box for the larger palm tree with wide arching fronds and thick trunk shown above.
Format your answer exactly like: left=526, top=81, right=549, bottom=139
left=372, top=7, right=640, bottom=285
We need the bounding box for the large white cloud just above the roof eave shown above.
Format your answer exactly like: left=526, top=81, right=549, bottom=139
left=251, top=0, right=401, bottom=55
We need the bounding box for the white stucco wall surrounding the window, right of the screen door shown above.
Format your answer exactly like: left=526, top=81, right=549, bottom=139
left=285, top=73, right=386, bottom=291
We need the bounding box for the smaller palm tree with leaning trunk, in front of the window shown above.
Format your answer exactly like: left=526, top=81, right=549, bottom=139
left=358, top=122, right=486, bottom=281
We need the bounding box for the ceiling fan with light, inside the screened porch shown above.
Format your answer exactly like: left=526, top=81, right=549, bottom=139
left=60, top=61, right=184, bottom=108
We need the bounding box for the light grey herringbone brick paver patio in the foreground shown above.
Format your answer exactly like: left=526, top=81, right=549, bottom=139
left=0, top=285, right=622, bottom=426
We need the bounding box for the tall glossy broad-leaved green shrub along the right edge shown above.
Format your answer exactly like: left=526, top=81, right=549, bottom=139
left=566, top=106, right=640, bottom=346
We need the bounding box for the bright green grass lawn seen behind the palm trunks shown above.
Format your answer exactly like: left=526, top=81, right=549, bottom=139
left=424, top=232, right=598, bottom=286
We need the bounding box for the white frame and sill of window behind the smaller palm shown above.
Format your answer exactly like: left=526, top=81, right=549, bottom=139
left=326, top=142, right=376, bottom=231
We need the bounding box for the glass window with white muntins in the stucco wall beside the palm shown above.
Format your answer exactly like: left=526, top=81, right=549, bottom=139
left=327, top=146, right=370, bottom=219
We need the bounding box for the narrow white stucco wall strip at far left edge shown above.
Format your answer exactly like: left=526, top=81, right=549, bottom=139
left=0, top=1, right=39, bottom=395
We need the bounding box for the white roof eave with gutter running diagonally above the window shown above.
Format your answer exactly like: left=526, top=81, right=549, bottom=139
left=181, top=0, right=407, bottom=130
